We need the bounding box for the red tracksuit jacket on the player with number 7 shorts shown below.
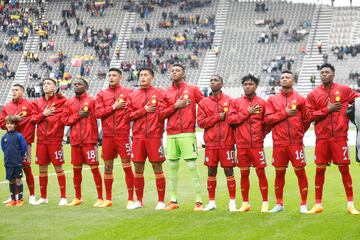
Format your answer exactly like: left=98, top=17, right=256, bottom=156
left=306, top=83, right=359, bottom=140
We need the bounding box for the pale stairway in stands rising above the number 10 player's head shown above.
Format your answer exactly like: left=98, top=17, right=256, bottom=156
left=197, top=0, right=230, bottom=88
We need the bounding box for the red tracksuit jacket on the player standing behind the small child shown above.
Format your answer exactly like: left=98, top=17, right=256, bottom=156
left=0, top=98, right=35, bottom=144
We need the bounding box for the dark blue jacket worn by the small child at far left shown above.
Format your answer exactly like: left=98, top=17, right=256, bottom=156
left=1, top=131, right=27, bottom=167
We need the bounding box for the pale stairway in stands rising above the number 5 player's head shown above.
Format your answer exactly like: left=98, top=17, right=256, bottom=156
left=103, top=6, right=137, bottom=89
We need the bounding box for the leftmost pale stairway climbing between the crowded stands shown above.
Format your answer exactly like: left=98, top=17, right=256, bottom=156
left=0, top=1, right=48, bottom=106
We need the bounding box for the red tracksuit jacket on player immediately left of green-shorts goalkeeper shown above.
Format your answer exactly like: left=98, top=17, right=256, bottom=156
left=126, top=86, right=168, bottom=138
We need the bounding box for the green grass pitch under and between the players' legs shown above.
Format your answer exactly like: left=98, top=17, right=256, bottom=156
left=0, top=145, right=360, bottom=240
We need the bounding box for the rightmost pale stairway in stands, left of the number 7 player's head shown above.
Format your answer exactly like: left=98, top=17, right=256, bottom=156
left=296, top=5, right=333, bottom=96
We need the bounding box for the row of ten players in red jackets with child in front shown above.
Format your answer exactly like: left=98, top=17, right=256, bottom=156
left=0, top=64, right=360, bottom=214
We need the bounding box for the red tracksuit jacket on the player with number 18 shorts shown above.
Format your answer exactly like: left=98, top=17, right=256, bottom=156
left=63, top=92, right=98, bottom=146
